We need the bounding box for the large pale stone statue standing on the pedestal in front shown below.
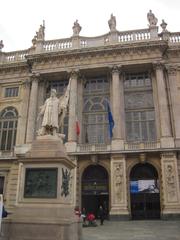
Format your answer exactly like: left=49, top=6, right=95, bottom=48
left=38, top=79, right=71, bottom=136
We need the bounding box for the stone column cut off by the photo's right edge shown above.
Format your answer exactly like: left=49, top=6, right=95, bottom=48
left=166, top=66, right=180, bottom=147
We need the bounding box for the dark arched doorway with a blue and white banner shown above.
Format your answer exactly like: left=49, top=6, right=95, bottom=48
left=130, top=163, right=160, bottom=219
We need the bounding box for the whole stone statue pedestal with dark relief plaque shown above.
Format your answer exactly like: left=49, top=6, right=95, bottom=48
left=3, top=135, right=81, bottom=240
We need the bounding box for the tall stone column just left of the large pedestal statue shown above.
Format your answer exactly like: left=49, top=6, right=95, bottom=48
left=26, top=74, right=39, bottom=143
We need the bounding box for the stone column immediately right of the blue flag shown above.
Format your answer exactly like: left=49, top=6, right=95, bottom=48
left=111, top=67, right=125, bottom=150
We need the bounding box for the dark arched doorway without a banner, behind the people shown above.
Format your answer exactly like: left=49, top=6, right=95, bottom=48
left=82, top=165, right=109, bottom=218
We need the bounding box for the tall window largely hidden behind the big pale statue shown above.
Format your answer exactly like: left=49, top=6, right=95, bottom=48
left=46, top=80, right=69, bottom=142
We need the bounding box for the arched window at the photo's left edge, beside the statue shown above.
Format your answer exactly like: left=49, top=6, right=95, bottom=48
left=0, top=107, right=18, bottom=151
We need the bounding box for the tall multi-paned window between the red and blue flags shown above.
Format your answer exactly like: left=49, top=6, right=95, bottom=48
left=83, top=77, right=109, bottom=143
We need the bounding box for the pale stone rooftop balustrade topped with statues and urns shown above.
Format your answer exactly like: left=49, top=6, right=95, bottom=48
left=0, top=10, right=180, bottom=64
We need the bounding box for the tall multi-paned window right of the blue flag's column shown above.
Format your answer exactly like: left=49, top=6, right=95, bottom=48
left=124, top=73, right=156, bottom=141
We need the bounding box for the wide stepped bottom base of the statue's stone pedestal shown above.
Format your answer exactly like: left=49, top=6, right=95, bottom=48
left=0, top=207, right=82, bottom=240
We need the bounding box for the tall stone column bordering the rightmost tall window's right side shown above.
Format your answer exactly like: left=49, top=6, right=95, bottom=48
left=154, top=63, right=174, bottom=148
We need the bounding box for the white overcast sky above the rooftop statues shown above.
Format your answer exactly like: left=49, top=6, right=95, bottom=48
left=0, top=0, right=180, bottom=52
